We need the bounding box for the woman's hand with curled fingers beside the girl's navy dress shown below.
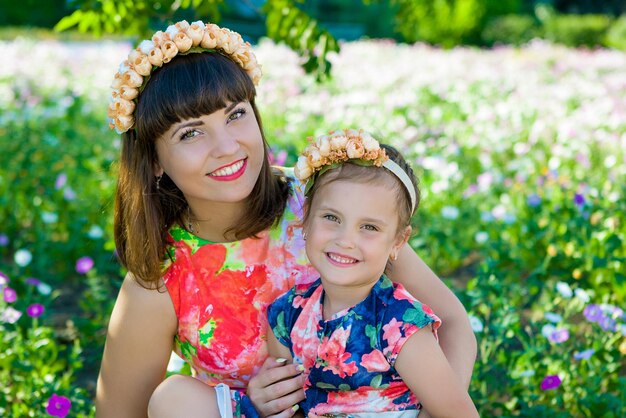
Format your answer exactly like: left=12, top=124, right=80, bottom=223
left=247, top=357, right=304, bottom=418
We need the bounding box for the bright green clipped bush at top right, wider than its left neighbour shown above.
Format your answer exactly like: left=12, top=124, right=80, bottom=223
left=543, top=15, right=611, bottom=47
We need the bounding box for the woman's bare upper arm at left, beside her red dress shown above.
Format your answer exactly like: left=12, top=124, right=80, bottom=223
left=96, top=274, right=177, bottom=418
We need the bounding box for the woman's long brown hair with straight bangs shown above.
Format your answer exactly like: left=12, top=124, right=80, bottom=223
left=114, top=52, right=290, bottom=287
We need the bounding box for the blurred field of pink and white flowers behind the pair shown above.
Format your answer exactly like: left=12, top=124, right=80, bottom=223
left=0, top=39, right=626, bottom=417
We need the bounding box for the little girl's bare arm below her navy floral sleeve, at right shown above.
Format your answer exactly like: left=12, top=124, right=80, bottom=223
left=395, top=327, right=478, bottom=418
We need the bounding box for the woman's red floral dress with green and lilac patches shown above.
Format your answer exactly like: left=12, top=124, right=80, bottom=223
left=163, top=176, right=318, bottom=404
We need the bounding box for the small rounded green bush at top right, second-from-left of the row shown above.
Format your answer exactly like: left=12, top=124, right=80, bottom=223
left=481, top=15, right=540, bottom=45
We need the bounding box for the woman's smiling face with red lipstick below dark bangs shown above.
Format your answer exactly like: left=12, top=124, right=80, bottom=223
left=155, top=102, right=264, bottom=209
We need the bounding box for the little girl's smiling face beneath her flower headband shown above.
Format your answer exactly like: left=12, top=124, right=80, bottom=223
left=305, top=180, right=410, bottom=287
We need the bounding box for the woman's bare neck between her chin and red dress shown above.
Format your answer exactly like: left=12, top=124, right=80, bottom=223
left=185, top=198, right=244, bottom=242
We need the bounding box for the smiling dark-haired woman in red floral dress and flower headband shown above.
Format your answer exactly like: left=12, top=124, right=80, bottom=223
left=96, top=21, right=475, bottom=418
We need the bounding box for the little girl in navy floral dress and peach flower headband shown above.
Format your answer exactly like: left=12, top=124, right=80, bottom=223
left=268, top=130, right=478, bottom=418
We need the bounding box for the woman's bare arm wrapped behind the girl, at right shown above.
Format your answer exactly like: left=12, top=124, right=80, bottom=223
left=389, top=244, right=476, bottom=388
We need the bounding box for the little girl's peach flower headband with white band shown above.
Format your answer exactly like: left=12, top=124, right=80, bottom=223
left=294, top=129, right=416, bottom=212
